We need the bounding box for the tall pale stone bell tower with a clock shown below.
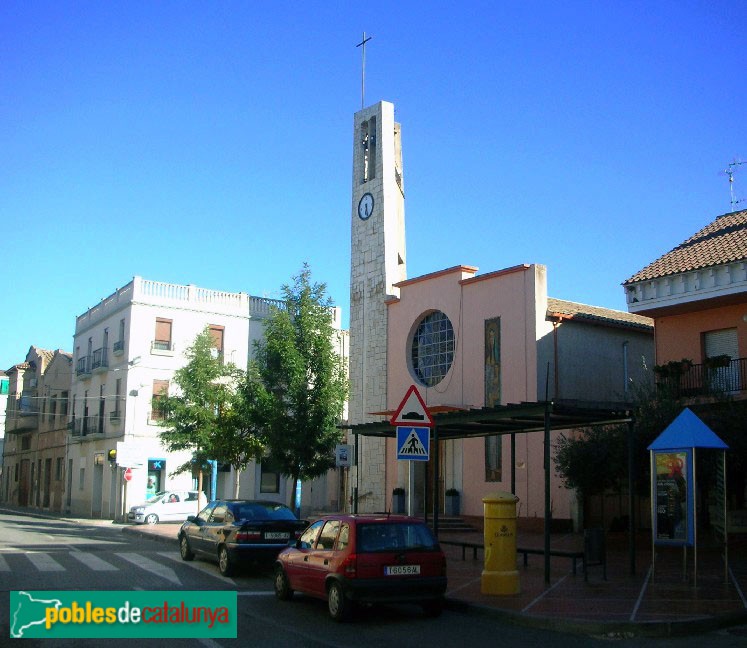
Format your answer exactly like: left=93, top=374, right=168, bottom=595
left=348, top=101, right=407, bottom=512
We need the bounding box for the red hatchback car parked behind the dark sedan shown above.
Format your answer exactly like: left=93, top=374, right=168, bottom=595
left=275, top=514, right=446, bottom=621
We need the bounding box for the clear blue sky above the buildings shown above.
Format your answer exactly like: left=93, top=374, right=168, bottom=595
left=0, top=0, right=747, bottom=369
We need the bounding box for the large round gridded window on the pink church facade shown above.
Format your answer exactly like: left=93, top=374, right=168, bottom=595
left=410, top=311, right=454, bottom=387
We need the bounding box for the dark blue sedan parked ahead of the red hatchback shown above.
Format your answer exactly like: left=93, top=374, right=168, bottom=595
left=179, top=499, right=307, bottom=576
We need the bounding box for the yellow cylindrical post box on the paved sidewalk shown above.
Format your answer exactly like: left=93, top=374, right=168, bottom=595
left=480, top=491, right=521, bottom=594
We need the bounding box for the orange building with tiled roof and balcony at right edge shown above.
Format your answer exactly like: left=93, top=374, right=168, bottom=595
left=623, top=210, right=747, bottom=398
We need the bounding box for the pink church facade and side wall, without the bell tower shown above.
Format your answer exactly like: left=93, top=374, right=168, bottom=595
left=386, top=264, right=653, bottom=521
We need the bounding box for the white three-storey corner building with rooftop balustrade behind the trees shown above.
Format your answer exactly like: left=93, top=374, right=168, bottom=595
left=65, top=277, right=348, bottom=519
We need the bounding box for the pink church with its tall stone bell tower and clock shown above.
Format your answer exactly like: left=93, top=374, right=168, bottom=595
left=346, top=101, right=654, bottom=525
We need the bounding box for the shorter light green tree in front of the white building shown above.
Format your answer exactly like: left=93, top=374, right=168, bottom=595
left=158, top=327, right=263, bottom=502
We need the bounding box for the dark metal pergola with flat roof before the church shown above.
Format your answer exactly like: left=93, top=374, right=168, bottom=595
left=343, top=400, right=635, bottom=583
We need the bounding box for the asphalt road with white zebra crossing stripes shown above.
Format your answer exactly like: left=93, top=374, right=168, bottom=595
left=0, top=514, right=747, bottom=648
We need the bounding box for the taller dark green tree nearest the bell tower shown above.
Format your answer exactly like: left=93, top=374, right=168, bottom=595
left=255, top=264, right=347, bottom=508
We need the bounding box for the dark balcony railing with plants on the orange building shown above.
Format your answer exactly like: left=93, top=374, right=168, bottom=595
left=656, top=358, right=747, bottom=398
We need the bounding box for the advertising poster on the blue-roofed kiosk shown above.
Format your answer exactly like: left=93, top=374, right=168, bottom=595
left=654, top=450, right=693, bottom=545
